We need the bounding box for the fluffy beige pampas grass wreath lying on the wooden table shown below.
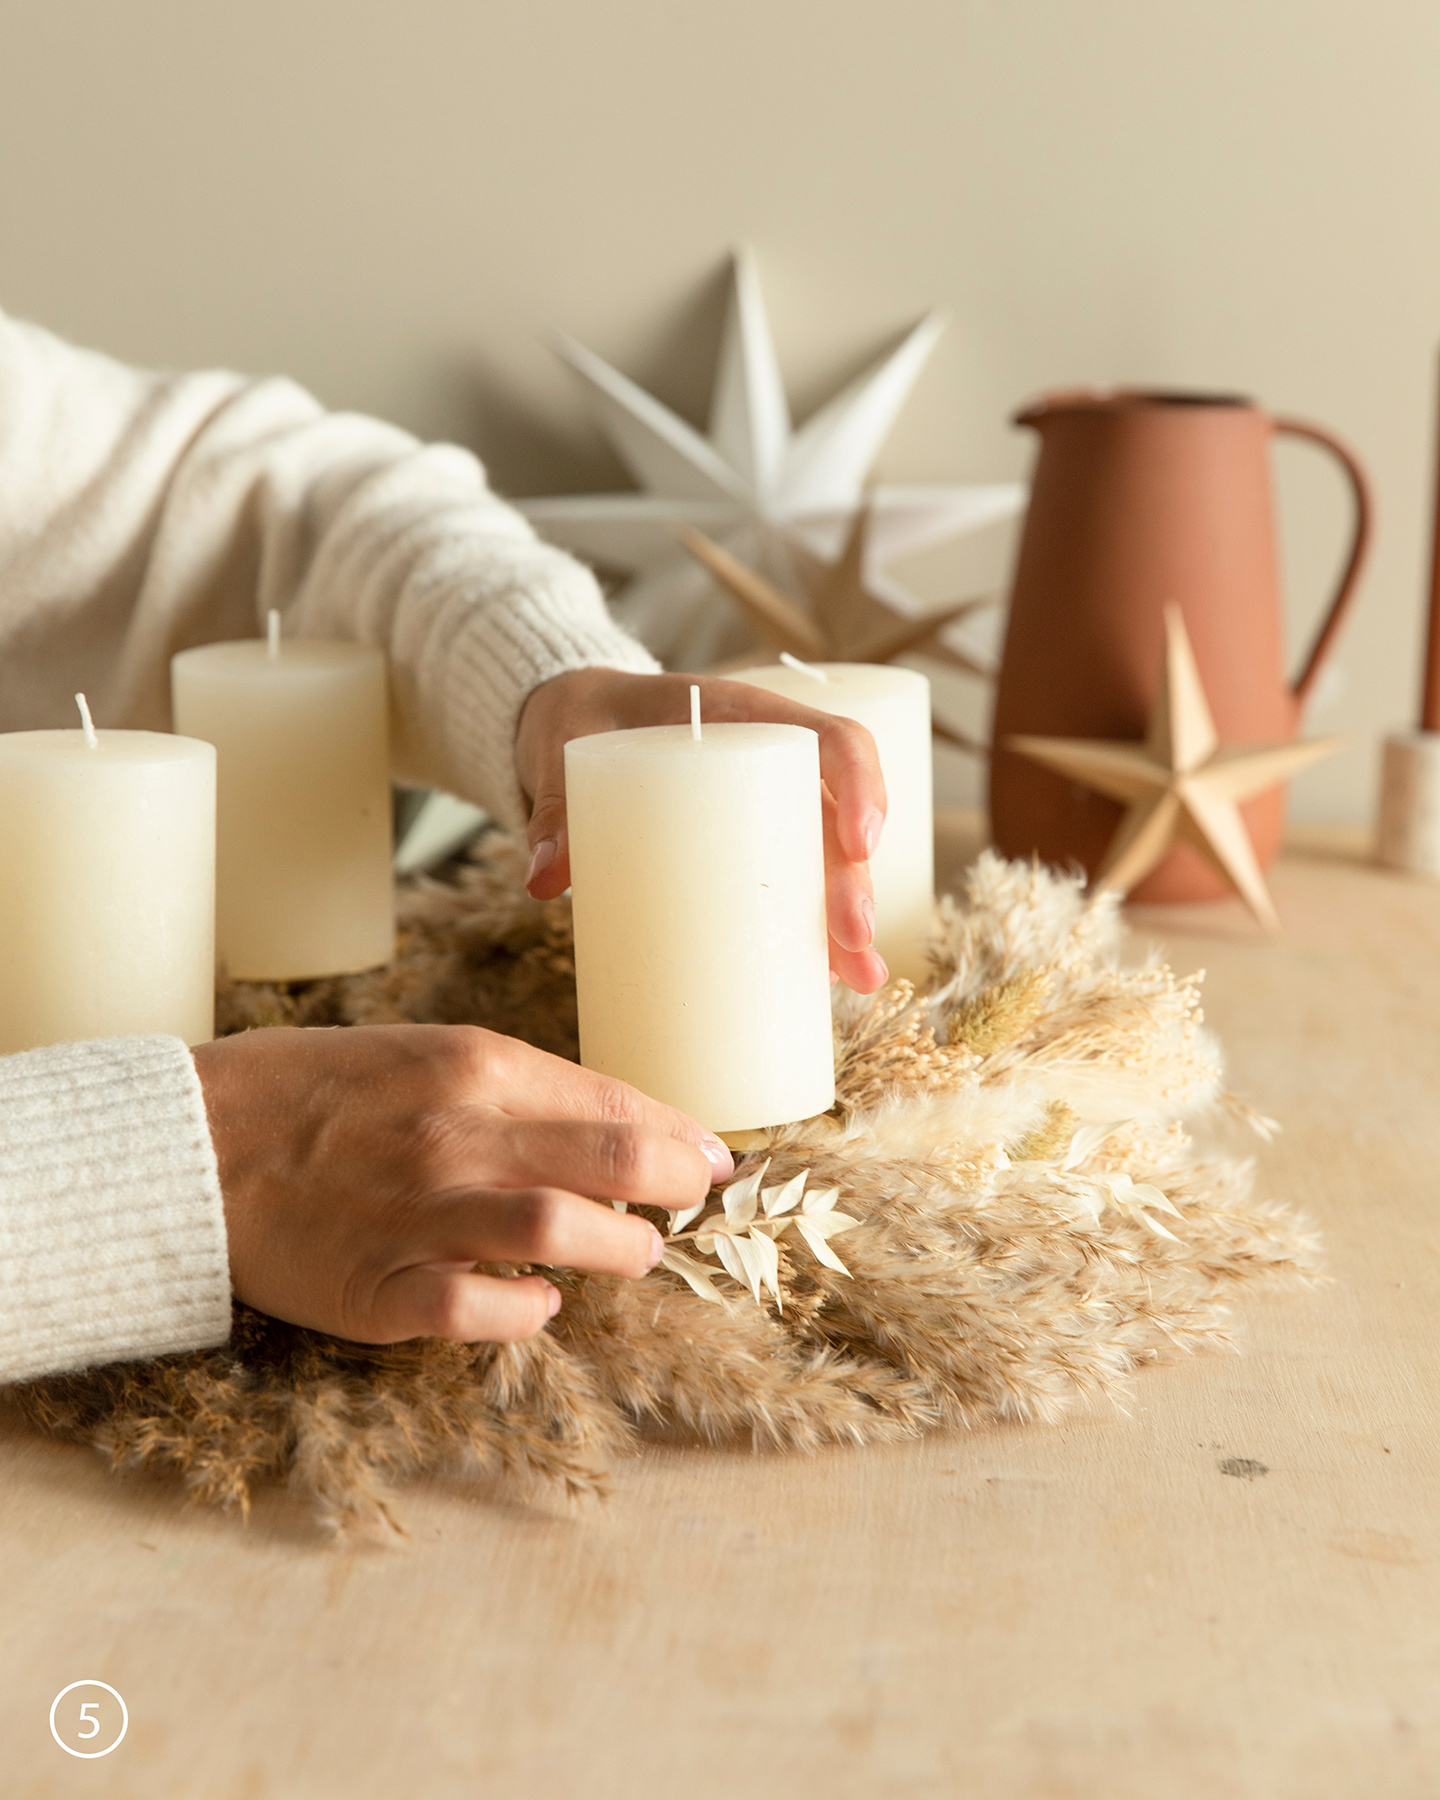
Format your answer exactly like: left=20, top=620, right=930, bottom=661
left=16, top=835, right=1316, bottom=1534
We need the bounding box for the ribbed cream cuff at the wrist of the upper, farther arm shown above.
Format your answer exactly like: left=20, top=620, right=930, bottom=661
left=443, top=553, right=661, bottom=826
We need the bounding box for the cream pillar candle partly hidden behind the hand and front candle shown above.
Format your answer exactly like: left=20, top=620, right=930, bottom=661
left=729, top=662, right=934, bottom=983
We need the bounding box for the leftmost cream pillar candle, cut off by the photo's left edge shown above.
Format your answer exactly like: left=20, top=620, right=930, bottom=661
left=0, top=731, right=214, bottom=1055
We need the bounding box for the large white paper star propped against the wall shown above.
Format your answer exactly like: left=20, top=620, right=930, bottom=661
left=520, top=252, right=1026, bottom=668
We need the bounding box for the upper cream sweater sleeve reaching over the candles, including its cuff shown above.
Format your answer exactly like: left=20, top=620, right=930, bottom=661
left=0, top=313, right=657, bottom=823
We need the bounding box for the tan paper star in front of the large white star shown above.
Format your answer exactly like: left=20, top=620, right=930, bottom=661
left=680, top=502, right=992, bottom=754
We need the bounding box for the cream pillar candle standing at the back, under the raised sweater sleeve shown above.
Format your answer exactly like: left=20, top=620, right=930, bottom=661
left=171, top=639, right=394, bottom=981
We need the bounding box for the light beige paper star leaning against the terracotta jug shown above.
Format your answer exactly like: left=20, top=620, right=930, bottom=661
left=1006, top=607, right=1341, bottom=931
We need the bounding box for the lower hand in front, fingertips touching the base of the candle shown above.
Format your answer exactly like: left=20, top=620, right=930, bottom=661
left=194, top=1024, right=734, bottom=1343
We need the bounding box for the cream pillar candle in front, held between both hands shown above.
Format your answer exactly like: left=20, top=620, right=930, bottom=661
left=565, top=724, right=835, bottom=1132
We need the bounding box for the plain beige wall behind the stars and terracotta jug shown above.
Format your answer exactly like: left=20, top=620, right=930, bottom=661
left=0, top=0, right=1440, bottom=817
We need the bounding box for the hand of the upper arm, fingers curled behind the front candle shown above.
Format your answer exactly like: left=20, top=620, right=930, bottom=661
left=515, top=670, right=887, bottom=994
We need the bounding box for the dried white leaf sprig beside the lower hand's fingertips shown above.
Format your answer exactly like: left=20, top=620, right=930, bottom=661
left=661, top=1157, right=860, bottom=1310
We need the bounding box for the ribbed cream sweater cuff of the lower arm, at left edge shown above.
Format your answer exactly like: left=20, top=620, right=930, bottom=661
left=0, top=1037, right=230, bottom=1381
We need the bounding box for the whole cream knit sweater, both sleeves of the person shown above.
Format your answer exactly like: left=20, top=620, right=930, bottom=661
left=0, top=313, right=655, bottom=1381
